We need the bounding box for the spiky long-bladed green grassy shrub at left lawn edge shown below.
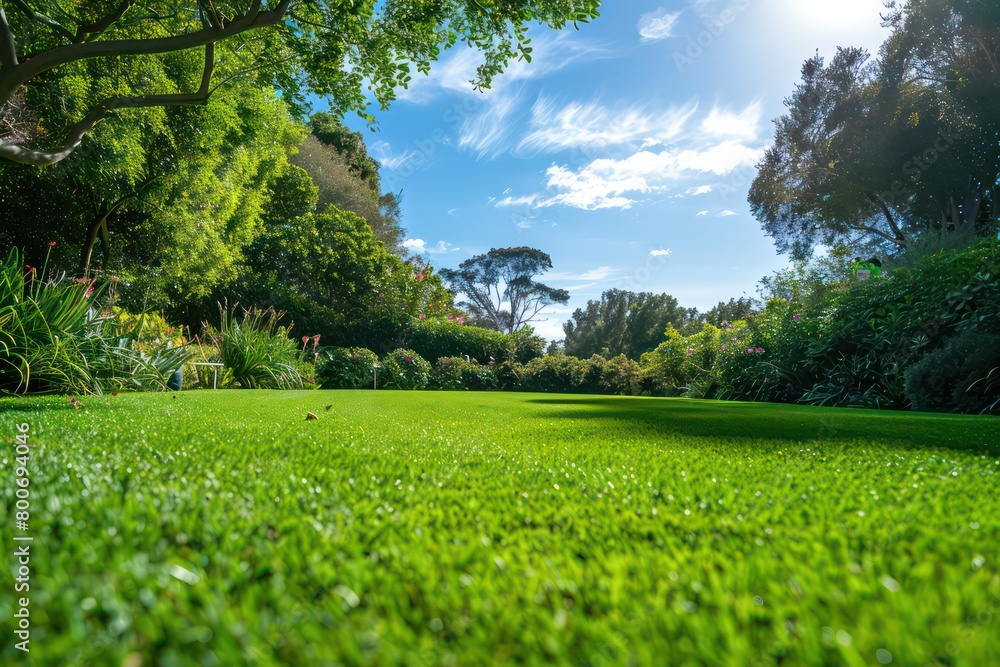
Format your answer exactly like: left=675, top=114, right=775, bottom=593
left=206, top=304, right=302, bottom=389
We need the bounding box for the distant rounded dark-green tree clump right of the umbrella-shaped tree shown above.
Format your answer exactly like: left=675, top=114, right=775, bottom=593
left=563, top=289, right=697, bottom=360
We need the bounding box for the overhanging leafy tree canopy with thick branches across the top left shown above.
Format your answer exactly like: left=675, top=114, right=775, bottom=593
left=0, top=0, right=599, bottom=166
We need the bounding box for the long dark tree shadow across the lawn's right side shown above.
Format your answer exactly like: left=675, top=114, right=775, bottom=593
left=527, top=396, right=1000, bottom=453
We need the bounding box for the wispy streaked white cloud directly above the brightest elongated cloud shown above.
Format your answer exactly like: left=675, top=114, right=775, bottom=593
left=518, top=97, right=698, bottom=153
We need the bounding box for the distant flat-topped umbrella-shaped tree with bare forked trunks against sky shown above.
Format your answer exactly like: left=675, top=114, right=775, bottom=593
left=441, top=246, right=569, bottom=333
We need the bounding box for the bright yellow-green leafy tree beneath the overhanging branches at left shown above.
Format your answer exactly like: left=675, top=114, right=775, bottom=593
left=0, top=83, right=304, bottom=288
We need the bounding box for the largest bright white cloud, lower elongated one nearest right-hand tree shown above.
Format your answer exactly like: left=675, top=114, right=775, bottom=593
left=537, top=141, right=764, bottom=210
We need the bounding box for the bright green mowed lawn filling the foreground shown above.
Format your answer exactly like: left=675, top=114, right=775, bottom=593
left=0, top=391, right=1000, bottom=667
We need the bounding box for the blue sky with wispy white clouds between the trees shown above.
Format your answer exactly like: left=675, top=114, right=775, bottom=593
left=348, top=0, right=887, bottom=339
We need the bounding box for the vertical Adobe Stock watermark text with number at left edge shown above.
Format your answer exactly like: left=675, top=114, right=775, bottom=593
left=13, top=424, right=34, bottom=653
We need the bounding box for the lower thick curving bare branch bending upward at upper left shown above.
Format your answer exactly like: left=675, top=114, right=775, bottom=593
left=0, top=43, right=215, bottom=167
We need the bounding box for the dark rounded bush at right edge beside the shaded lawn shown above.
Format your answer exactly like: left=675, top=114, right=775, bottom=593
left=905, top=330, right=1000, bottom=413
